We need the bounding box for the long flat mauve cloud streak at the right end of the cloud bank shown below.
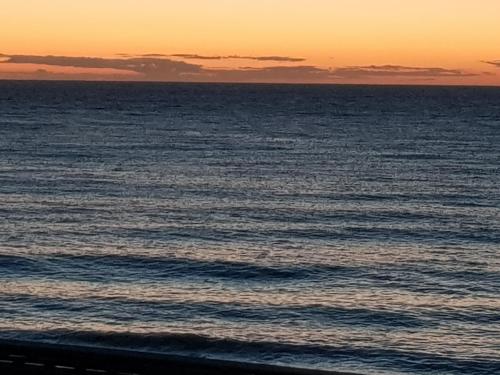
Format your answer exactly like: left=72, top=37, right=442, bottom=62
left=332, top=65, right=477, bottom=79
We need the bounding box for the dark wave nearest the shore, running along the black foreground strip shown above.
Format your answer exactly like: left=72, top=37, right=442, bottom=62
left=0, top=330, right=500, bottom=375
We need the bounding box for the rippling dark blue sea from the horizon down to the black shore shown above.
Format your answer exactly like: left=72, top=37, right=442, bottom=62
left=0, top=82, right=500, bottom=374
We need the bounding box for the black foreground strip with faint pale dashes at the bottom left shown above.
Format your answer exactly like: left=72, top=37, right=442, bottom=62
left=0, top=340, right=360, bottom=375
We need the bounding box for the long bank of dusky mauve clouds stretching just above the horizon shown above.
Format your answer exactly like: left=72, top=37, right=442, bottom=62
left=0, top=54, right=478, bottom=83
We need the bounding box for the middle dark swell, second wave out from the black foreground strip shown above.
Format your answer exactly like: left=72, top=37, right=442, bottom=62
left=0, top=291, right=442, bottom=330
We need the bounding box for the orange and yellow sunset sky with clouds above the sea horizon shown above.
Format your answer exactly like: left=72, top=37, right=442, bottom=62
left=0, top=0, right=500, bottom=86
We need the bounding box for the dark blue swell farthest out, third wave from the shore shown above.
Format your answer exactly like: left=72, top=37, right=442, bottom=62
left=0, top=254, right=500, bottom=295
